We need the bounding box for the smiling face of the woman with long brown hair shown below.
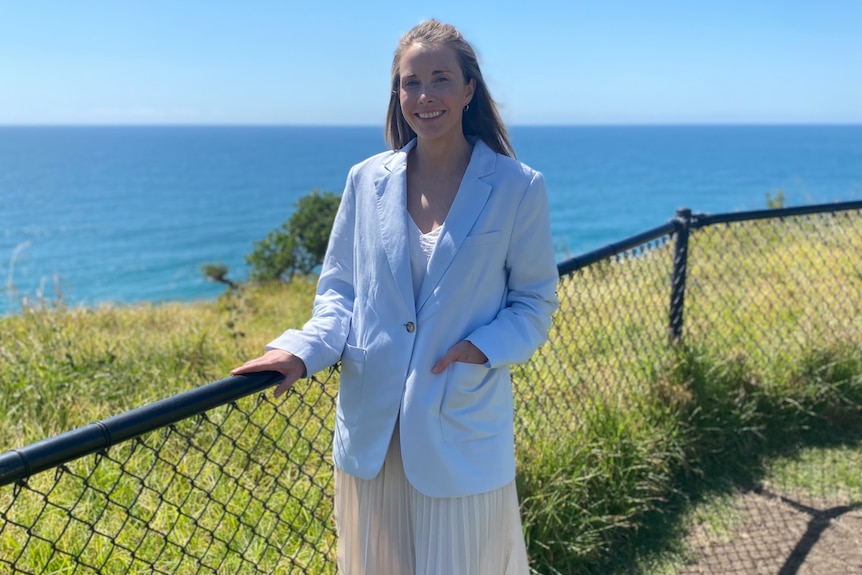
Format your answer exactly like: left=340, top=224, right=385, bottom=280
left=398, top=44, right=476, bottom=145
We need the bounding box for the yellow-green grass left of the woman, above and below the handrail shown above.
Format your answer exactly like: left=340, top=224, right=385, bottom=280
left=0, top=282, right=335, bottom=573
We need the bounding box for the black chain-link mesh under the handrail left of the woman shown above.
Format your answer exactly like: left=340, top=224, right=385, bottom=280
left=0, top=379, right=336, bottom=574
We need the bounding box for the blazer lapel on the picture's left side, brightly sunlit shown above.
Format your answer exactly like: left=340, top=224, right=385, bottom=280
left=374, top=141, right=415, bottom=316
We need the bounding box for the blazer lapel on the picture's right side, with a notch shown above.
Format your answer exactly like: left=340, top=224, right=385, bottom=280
left=416, top=140, right=496, bottom=312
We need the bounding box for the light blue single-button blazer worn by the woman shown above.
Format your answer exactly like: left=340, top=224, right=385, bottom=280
left=274, top=140, right=558, bottom=497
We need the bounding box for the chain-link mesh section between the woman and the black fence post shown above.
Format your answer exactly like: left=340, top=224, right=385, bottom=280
left=512, top=236, right=673, bottom=441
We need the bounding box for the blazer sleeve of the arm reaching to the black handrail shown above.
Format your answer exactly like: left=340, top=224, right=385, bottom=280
left=266, top=168, right=356, bottom=375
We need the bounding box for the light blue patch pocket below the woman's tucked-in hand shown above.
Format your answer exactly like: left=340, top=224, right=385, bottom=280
left=440, top=362, right=511, bottom=443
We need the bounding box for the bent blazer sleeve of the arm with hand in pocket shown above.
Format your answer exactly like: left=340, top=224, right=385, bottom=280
left=466, top=172, right=559, bottom=368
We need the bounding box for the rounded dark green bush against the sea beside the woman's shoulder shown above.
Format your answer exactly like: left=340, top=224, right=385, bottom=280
left=245, top=189, right=341, bottom=282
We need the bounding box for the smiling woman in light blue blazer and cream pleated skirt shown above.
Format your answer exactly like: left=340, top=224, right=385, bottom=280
left=233, top=20, right=557, bottom=575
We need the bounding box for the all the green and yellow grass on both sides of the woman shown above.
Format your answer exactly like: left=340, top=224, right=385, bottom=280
left=0, top=209, right=862, bottom=575
